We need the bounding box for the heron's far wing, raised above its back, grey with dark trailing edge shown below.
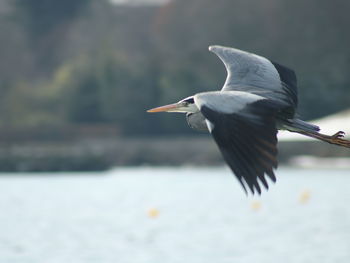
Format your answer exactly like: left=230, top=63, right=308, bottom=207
left=209, top=46, right=298, bottom=115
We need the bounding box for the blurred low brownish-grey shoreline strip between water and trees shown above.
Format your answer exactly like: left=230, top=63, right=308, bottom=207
left=0, top=136, right=350, bottom=172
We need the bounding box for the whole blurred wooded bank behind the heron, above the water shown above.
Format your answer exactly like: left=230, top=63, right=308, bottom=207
left=0, top=0, right=350, bottom=171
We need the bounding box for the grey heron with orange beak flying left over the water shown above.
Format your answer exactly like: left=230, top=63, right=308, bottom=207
left=148, top=45, right=350, bottom=195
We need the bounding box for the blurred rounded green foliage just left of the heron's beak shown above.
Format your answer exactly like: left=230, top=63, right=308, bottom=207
left=47, top=50, right=161, bottom=133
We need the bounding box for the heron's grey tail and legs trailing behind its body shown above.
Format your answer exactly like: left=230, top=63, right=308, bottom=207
left=284, top=119, right=350, bottom=148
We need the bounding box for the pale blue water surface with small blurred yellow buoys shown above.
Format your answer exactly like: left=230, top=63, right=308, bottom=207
left=0, top=168, right=350, bottom=263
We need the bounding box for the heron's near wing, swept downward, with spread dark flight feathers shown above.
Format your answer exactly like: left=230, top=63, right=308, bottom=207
left=194, top=91, right=280, bottom=194
